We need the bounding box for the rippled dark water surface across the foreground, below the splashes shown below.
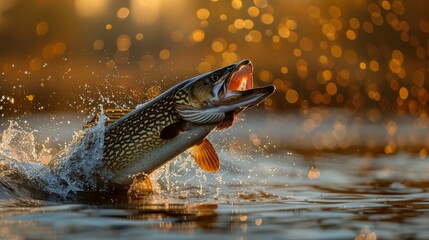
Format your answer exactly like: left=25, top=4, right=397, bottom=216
left=0, top=154, right=429, bottom=239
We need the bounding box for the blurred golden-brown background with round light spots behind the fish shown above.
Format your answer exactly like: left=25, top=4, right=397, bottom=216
left=0, top=0, right=429, bottom=154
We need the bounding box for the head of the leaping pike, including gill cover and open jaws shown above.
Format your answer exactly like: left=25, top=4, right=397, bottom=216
left=176, top=60, right=275, bottom=124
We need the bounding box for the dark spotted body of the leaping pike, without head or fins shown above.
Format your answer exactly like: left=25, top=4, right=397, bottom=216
left=103, top=82, right=212, bottom=184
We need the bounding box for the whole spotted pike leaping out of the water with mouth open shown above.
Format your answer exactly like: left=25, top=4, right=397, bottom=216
left=78, top=60, right=275, bottom=193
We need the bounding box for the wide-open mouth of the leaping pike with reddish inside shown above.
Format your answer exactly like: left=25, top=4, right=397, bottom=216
left=212, top=60, right=275, bottom=112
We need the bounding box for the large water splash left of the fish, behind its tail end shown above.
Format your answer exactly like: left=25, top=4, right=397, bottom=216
left=0, top=116, right=110, bottom=198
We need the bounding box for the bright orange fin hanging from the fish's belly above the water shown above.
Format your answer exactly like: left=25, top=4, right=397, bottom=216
left=192, top=138, right=220, bottom=172
